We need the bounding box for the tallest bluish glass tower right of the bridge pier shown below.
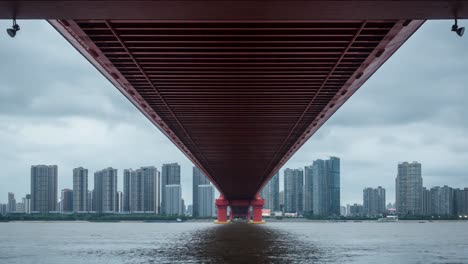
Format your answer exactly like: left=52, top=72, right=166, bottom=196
left=312, top=157, right=340, bottom=216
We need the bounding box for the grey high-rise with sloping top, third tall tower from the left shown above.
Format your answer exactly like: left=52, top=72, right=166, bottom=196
left=93, top=167, right=118, bottom=213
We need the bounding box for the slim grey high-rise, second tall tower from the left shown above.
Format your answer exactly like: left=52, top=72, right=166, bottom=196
left=73, top=167, right=89, bottom=212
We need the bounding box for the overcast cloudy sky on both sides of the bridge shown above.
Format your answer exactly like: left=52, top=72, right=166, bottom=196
left=0, top=20, right=468, bottom=204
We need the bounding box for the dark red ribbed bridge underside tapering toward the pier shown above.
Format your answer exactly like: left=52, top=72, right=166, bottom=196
left=51, top=20, right=422, bottom=200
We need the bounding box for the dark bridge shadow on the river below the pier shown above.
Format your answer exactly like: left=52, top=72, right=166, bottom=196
left=172, top=223, right=322, bottom=263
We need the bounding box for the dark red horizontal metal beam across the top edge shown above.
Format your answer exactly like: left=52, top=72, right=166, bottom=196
left=0, top=0, right=468, bottom=19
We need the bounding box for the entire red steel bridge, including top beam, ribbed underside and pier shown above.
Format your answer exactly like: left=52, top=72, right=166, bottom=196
left=0, top=0, right=468, bottom=222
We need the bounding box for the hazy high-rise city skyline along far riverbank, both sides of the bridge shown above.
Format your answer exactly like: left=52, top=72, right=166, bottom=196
left=0, top=160, right=468, bottom=217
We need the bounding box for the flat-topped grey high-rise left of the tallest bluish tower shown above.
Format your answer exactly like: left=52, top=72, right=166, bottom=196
left=284, top=169, right=304, bottom=213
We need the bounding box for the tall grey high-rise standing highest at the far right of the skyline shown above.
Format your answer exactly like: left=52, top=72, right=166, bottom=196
left=395, top=162, right=423, bottom=215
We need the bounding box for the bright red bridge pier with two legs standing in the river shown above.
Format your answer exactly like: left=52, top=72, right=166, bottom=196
left=215, top=194, right=265, bottom=224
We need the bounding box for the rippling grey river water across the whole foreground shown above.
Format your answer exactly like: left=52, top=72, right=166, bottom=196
left=0, top=221, right=468, bottom=264
